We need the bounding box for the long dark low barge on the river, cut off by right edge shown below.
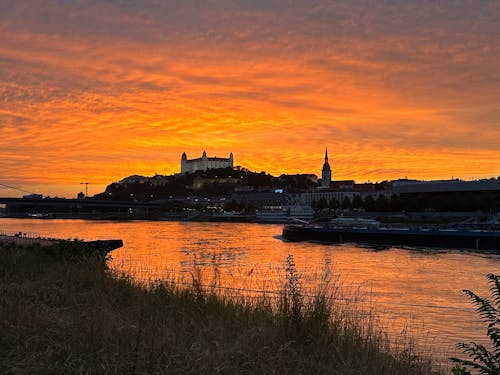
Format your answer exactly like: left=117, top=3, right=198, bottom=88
left=283, top=218, right=500, bottom=251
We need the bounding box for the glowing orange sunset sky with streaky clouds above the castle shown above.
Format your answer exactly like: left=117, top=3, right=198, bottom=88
left=0, top=0, right=500, bottom=197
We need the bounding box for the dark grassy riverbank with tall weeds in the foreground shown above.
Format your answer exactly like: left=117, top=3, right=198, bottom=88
left=0, top=245, right=438, bottom=375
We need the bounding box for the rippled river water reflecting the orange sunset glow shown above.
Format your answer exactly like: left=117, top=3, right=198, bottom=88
left=0, top=219, right=500, bottom=368
